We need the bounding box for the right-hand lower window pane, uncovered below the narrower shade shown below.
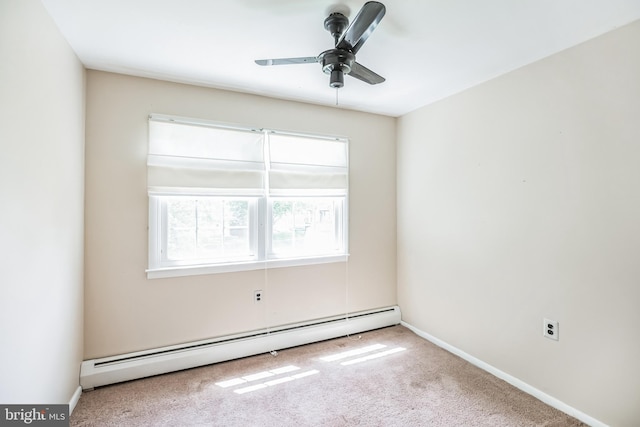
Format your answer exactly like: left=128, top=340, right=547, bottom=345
left=271, top=197, right=344, bottom=258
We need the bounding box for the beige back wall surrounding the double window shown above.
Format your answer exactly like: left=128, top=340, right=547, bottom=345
left=85, top=71, right=397, bottom=359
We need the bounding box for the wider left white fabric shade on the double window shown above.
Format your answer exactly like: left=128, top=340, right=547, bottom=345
left=147, top=116, right=265, bottom=192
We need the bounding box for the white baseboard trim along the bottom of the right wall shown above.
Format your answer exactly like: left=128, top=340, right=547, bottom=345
left=400, top=321, right=609, bottom=427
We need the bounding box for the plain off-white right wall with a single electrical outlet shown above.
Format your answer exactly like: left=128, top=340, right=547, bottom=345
left=398, top=18, right=640, bottom=427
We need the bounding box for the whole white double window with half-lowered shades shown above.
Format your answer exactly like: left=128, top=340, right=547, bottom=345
left=147, top=115, right=348, bottom=278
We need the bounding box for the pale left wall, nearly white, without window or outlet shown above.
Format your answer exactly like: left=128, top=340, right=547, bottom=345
left=0, top=0, right=84, bottom=404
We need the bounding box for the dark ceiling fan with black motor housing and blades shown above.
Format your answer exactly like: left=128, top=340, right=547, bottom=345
left=255, top=1, right=386, bottom=88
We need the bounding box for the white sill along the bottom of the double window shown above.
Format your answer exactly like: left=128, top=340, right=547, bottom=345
left=146, top=254, right=349, bottom=279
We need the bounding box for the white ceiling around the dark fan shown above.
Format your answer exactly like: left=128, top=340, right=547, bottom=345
left=42, top=0, right=640, bottom=116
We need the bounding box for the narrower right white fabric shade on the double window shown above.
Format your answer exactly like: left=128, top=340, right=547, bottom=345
left=269, top=133, right=349, bottom=192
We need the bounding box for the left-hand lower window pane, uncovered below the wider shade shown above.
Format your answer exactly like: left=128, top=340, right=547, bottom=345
left=165, top=197, right=253, bottom=263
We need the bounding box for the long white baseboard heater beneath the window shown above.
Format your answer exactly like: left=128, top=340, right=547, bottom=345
left=80, top=306, right=401, bottom=390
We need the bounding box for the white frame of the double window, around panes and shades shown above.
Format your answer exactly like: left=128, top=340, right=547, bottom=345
left=146, top=116, right=349, bottom=279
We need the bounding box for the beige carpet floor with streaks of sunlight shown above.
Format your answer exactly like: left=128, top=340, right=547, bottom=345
left=71, top=326, right=585, bottom=427
